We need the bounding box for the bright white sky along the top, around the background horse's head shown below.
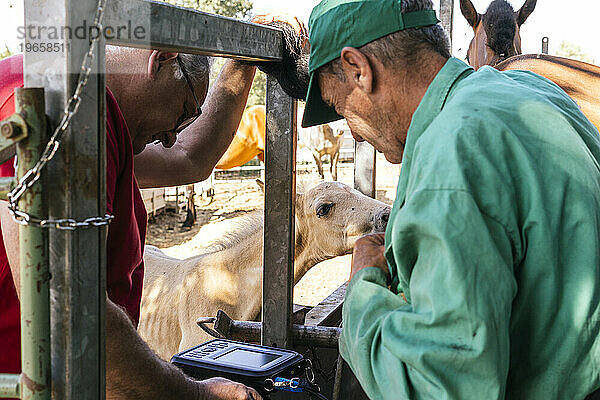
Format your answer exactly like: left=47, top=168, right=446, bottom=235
left=0, top=0, right=600, bottom=64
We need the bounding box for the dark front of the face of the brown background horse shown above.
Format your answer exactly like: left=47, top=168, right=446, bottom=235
left=482, top=0, right=516, bottom=55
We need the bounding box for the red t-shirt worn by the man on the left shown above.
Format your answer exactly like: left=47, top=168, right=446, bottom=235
left=0, top=55, right=147, bottom=373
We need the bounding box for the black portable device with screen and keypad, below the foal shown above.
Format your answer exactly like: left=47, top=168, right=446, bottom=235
left=171, top=339, right=327, bottom=400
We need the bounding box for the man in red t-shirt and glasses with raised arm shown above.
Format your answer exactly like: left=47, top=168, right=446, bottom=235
left=0, top=47, right=260, bottom=399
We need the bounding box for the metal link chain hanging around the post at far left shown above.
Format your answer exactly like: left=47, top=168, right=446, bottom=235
left=7, top=0, right=113, bottom=230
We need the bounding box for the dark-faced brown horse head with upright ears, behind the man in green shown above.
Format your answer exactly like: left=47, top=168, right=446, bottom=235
left=460, top=0, right=536, bottom=69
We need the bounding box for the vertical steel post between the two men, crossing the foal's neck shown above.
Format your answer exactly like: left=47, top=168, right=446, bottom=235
left=261, top=78, right=297, bottom=348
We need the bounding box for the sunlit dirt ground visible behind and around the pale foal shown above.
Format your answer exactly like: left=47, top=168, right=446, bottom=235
left=146, top=155, right=400, bottom=306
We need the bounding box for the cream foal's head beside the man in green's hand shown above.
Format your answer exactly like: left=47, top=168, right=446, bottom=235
left=296, top=182, right=390, bottom=276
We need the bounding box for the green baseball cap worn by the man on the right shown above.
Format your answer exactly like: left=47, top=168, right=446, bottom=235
left=302, top=0, right=440, bottom=128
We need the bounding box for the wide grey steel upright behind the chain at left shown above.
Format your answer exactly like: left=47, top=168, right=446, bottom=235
left=24, top=0, right=106, bottom=400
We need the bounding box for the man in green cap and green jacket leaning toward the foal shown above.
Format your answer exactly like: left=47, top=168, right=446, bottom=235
left=303, top=0, right=600, bottom=400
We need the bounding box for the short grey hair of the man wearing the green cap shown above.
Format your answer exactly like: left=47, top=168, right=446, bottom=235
left=319, top=0, right=450, bottom=80
